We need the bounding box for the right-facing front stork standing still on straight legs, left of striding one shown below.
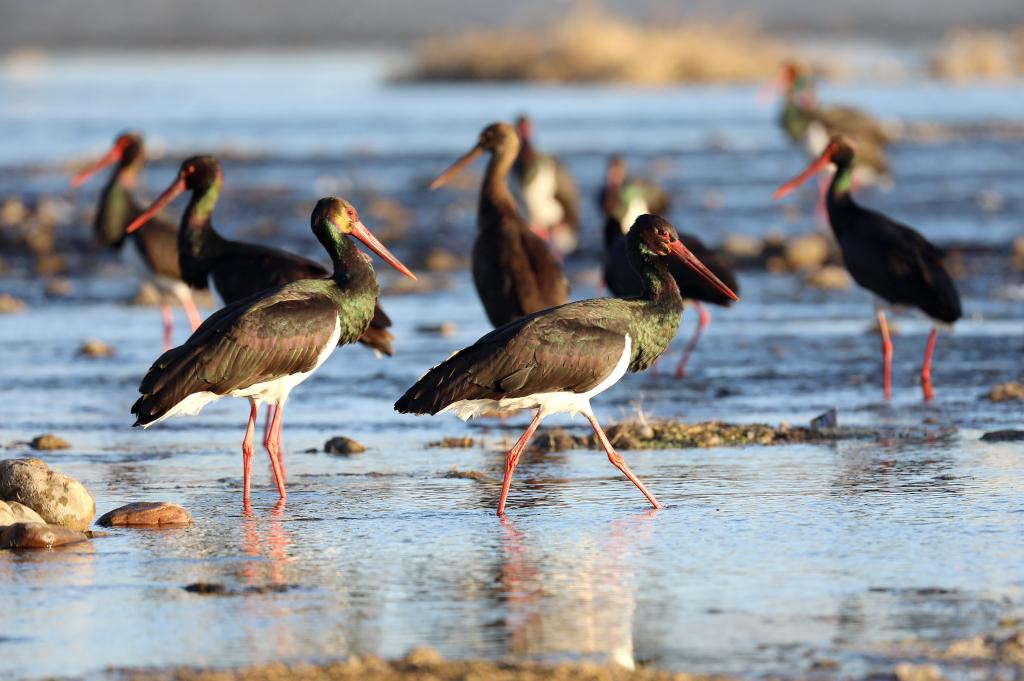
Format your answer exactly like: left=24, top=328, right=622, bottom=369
left=131, top=198, right=416, bottom=507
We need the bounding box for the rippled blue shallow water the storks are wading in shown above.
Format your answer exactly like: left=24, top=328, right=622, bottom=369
left=0, top=50, right=1024, bottom=676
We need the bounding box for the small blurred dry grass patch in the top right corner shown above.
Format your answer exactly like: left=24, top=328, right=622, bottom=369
left=929, top=26, right=1024, bottom=81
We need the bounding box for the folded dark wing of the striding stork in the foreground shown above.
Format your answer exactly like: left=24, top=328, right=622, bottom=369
left=394, top=298, right=630, bottom=414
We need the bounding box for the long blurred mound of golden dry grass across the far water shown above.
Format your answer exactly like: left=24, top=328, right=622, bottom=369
left=412, top=4, right=785, bottom=85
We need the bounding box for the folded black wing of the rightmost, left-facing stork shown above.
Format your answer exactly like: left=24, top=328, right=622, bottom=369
left=839, top=206, right=963, bottom=324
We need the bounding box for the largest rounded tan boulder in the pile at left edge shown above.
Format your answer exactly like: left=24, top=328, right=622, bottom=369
left=0, top=459, right=96, bottom=530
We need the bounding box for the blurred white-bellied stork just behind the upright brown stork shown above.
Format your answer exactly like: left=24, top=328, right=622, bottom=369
left=513, top=116, right=580, bottom=255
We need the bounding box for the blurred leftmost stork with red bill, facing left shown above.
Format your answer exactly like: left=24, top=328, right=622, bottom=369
left=71, top=132, right=203, bottom=350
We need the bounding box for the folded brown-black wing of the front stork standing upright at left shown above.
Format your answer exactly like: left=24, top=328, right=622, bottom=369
left=132, top=285, right=338, bottom=425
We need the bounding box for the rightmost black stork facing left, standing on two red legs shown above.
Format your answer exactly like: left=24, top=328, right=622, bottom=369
left=773, top=135, right=963, bottom=400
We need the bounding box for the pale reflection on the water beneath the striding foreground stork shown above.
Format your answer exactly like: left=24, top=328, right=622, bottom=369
left=501, top=509, right=657, bottom=669
